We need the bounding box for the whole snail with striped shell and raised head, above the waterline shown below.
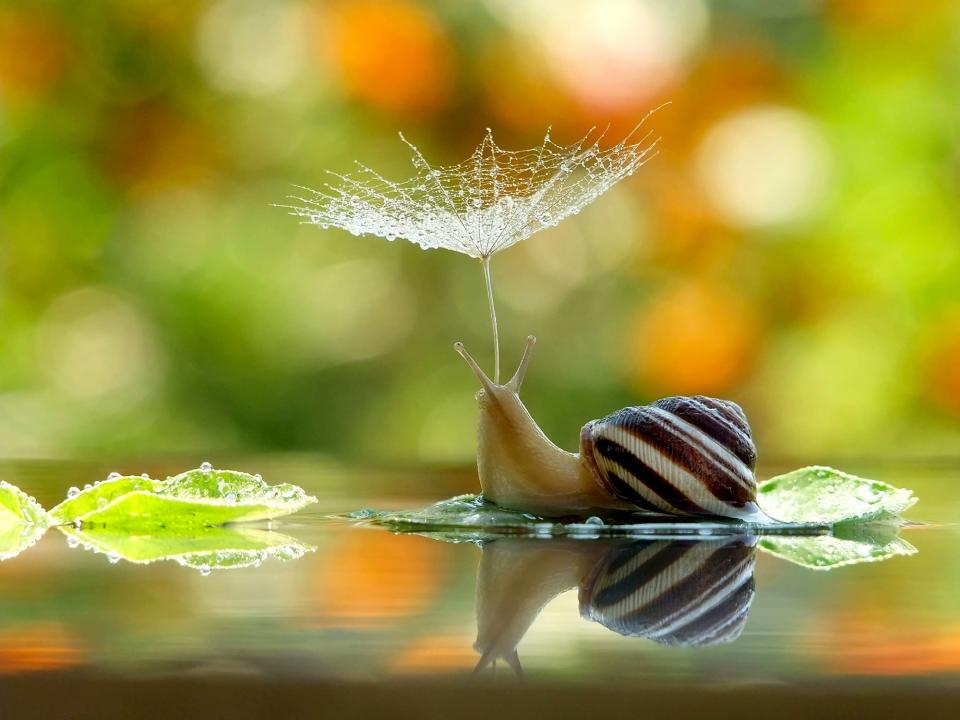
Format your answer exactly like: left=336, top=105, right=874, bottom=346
left=454, top=335, right=765, bottom=520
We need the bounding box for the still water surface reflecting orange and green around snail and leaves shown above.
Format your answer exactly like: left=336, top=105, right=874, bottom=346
left=0, top=458, right=960, bottom=716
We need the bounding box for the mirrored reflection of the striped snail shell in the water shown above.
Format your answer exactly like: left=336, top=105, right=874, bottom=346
left=580, top=538, right=755, bottom=647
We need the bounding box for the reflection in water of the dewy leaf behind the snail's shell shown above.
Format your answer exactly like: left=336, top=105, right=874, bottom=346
left=757, top=535, right=917, bottom=570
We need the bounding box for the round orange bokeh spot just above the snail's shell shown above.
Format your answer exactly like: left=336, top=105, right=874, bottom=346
left=630, top=284, right=757, bottom=393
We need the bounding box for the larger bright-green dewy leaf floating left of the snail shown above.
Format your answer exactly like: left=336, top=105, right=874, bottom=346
left=51, top=468, right=316, bottom=529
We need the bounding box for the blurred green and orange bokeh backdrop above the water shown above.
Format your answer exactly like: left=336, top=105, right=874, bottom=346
left=0, top=0, right=960, bottom=462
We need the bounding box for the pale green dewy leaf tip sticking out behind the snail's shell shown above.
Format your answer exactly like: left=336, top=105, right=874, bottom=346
left=757, top=465, right=917, bottom=523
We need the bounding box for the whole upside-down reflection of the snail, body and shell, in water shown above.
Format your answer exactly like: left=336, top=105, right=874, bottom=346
left=475, top=538, right=756, bottom=673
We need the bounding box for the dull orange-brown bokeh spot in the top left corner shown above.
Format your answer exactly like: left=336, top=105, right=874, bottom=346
left=0, top=8, right=69, bottom=98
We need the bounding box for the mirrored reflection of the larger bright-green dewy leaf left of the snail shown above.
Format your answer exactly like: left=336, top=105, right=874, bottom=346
left=59, top=526, right=315, bottom=572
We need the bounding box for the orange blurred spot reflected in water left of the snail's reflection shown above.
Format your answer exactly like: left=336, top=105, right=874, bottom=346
left=314, top=530, right=442, bottom=627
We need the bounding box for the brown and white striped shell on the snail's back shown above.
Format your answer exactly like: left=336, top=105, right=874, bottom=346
left=580, top=395, right=759, bottom=518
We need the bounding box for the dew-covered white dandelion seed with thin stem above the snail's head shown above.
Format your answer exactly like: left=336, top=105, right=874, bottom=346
left=279, top=108, right=659, bottom=382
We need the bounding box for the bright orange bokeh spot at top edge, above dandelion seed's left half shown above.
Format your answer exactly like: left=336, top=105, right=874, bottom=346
left=325, top=0, right=453, bottom=114
